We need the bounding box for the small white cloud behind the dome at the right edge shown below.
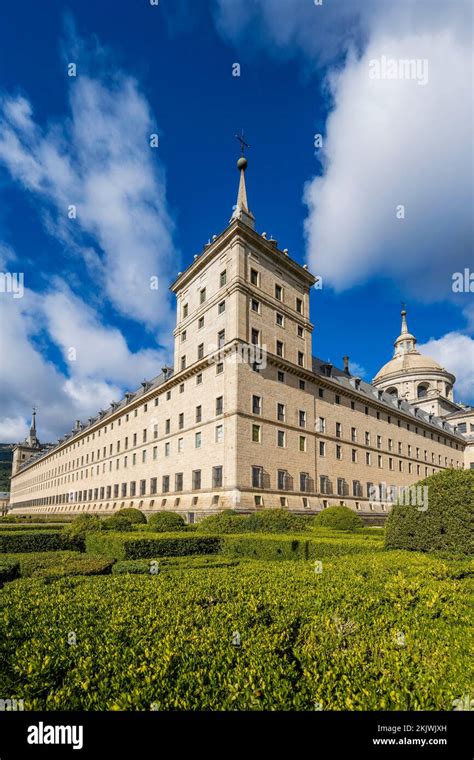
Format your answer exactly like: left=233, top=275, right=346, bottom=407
left=418, top=332, right=474, bottom=403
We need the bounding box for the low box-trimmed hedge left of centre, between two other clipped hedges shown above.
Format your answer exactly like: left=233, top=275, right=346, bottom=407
left=86, top=531, right=221, bottom=559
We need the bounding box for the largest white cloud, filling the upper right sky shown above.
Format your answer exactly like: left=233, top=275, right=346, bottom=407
left=215, top=0, right=473, bottom=300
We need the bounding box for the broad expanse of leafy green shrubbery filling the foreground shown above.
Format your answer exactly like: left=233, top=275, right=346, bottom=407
left=0, top=548, right=472, bottom=712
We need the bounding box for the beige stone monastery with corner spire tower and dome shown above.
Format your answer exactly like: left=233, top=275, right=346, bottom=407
left=7, top=156, right=474, bottom=522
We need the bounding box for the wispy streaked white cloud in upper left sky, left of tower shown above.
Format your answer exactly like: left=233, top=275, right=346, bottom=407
left=0, top=67, right=178, bottom=334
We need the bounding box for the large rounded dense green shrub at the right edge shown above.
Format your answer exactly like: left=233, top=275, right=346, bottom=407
left=385, top=469, right=474, bottom=554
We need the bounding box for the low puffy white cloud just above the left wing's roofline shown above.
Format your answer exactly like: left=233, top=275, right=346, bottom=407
left=0, top=270, right=169, bottom=442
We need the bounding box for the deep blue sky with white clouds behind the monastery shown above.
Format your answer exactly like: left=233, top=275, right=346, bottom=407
left=0, top=0, right=474, bottom=441
